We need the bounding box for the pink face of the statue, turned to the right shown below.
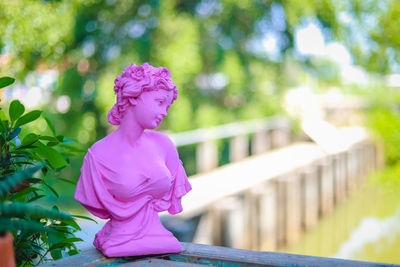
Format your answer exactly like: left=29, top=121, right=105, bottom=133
left=132, top=90, right=174, bottom=129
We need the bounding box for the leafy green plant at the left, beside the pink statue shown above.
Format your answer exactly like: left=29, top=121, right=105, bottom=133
left=0, top=78, right=86, bottom=266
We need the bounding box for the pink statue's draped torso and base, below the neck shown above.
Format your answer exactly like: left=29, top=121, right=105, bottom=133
left=75, top=132, right=191, bottom=257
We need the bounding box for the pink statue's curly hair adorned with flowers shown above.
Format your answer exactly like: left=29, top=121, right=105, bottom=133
left=107, top=62, right=178, bottom=125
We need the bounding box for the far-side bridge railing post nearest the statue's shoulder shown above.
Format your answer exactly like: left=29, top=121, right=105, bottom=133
left=196, top=140, right=218, bottom=173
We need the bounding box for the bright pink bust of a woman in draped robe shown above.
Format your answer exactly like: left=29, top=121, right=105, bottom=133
left=75, top=63, right=191, bottom=257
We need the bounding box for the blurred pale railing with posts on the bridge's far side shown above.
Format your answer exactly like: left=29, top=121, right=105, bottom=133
left=169, top=116, right=291, bottom=174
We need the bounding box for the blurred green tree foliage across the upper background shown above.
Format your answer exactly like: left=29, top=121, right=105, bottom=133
left=0, top=0, right=400, bottom=160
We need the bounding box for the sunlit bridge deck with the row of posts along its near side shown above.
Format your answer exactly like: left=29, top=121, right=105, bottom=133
left=162, top=126, right=376, bottom=251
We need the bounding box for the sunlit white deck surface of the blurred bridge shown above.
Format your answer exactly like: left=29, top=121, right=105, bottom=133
left=172, top=143, right=326, bottom=219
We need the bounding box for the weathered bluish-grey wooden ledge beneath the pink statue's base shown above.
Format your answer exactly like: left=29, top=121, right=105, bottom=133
left=41, top=242, right=400, bottom=267
